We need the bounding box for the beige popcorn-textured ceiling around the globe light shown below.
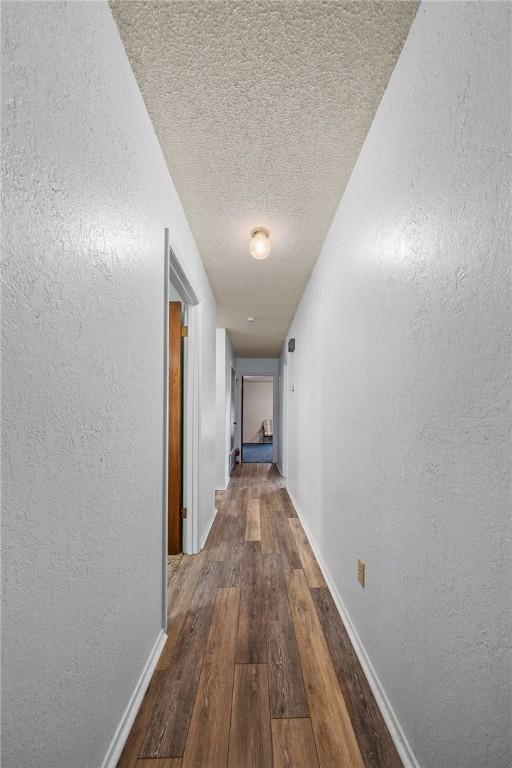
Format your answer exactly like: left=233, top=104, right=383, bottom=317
left=111, top=0, right=417, bottom=357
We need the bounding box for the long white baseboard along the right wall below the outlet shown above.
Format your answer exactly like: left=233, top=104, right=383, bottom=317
left=286, top=486, right=421, bottom=768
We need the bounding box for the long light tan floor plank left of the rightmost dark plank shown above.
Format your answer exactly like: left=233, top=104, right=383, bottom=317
left=286, top=570, right=364, bottom=768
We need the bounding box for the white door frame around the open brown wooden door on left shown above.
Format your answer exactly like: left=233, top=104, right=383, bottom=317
left=162, top=227, right=201, bottom=627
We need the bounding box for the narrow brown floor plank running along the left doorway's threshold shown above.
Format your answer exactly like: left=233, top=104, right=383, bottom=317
left=156, top=551, right=205, bottom=670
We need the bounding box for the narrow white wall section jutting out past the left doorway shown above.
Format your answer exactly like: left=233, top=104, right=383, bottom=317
left=215, top=328, right=235, bottom=491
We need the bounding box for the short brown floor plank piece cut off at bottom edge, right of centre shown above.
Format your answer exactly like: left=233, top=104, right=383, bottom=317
left=272, top=717, right=318, bottom=768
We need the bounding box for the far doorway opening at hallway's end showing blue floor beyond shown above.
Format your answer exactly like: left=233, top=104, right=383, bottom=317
left=241, top=376, right=274, bottom=464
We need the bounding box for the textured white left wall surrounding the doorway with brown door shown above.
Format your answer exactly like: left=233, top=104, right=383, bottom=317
left=2, top=2, right=215, bottom=768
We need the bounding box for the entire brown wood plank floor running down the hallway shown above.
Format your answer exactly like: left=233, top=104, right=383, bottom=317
left=118, top=464, right=402, bottom=768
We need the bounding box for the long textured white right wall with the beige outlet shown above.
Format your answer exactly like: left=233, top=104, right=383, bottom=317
left=287, top=2, right=512, bottom=768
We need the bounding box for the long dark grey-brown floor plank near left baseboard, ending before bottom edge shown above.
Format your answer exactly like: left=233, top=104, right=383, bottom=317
left=140, top=561, right=224, bottom=757
